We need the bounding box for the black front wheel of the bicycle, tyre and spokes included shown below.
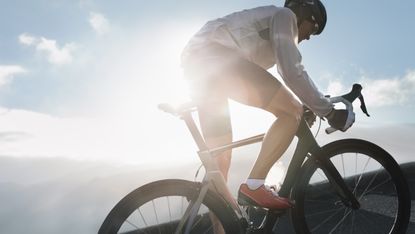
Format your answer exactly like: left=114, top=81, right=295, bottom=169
left=291, top=139, right=411, bottom=234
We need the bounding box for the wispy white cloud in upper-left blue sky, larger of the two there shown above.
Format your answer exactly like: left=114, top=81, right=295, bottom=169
left=19, top=33, right=76, bottom=65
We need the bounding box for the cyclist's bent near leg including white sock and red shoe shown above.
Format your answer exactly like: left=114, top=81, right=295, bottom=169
left=221, top=60, right=303, bottom=209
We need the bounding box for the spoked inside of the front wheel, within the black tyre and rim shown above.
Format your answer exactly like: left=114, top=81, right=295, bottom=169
left=304, top=153, right=398, bottom=233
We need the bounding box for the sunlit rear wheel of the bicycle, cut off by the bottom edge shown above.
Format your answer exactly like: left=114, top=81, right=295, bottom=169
left=98, top=180, right=240, bottom=234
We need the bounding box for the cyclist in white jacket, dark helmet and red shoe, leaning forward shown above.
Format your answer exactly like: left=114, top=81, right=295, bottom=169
left=182, top=0, right=354, bottom=209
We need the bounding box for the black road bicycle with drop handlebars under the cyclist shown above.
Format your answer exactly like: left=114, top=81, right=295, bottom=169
left=99, top=84, right=411, bottom=234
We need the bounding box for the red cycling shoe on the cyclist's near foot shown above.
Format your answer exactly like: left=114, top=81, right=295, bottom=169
left=238, top=184, right=294, bottom=210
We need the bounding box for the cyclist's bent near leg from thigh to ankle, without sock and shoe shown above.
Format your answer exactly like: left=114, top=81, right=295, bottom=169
left=216, top=63, right=303, bottom=182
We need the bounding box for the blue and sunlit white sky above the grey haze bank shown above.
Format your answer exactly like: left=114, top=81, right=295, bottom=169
left=0, top=0, right=415, bottom=163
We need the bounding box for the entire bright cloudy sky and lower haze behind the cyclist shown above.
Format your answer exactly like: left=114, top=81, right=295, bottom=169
left=0, top=0, right=415, bottom=233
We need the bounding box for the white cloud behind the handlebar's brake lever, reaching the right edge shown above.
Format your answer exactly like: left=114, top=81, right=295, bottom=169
left=327, top=70, right=415, bottom=107
